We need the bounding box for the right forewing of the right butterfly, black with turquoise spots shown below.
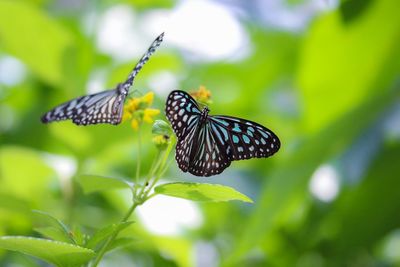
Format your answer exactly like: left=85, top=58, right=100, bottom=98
left=209, top=116, right=281, bottom=160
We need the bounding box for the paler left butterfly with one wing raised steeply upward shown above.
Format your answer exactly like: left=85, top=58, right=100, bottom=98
left=41, top=33, right=164, bottom=125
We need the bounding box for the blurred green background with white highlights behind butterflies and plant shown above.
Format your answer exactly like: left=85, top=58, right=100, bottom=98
left=0, top=0, right=400, bottom=267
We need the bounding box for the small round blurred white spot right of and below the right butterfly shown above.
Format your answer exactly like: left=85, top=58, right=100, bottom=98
left=309, top=164, right=339, bottom=202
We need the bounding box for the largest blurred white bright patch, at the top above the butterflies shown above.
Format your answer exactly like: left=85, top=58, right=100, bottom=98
left=144, top=0, right=251, bottom=61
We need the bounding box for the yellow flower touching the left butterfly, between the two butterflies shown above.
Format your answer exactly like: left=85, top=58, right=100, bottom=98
left=122, top=92, right=160, bottom=130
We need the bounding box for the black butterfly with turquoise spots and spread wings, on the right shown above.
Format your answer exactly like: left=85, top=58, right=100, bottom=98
left=165, top=90, right=281, bottom=176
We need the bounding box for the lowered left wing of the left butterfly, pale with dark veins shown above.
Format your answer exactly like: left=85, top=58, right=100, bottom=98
left=42, top=90, right=124, bottom=125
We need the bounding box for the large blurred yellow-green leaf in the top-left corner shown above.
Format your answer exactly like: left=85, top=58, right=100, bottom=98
left=0, top=1, right=73, bottom=84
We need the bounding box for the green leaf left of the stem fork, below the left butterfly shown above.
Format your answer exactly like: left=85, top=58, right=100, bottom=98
left=77, top=175, right=132, bottom=194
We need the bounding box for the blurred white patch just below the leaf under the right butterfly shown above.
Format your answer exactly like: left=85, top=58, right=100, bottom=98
left=137, top=195, right=203, bottom=235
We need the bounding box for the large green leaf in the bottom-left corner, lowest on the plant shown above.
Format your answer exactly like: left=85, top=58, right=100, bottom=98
left=0, top=236, right=95, bottom=267
